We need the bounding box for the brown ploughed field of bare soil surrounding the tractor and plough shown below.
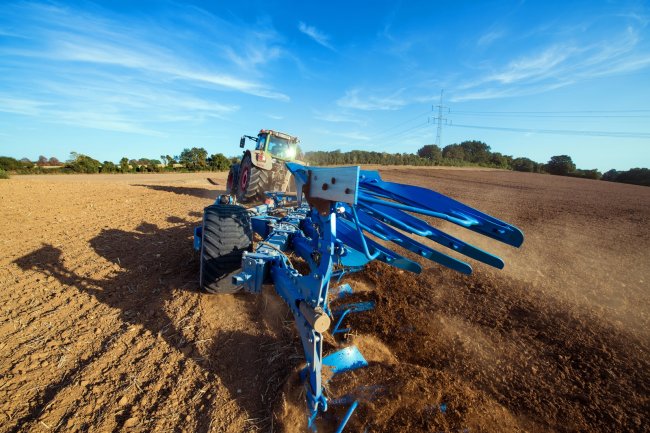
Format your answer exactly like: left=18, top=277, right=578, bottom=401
left=0, top=168, right=650, bottom=433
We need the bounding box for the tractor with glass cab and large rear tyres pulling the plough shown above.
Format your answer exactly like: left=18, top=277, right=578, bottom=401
left=226, top=129, right=300, bottom=203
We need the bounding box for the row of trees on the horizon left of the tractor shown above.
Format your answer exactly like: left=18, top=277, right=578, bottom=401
left=0, top=147, right=232, bottom=177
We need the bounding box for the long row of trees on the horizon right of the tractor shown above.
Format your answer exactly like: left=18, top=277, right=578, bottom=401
left=305, top=140, right=650, bottom=185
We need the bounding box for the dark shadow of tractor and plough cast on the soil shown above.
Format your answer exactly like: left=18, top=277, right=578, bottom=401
left=13, top=214, right=297, bottom=432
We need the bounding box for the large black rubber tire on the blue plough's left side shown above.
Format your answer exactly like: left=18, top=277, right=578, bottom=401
left=199, top=205, right=253, bottom=293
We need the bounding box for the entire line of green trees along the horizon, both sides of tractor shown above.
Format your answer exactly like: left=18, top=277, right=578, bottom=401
left=0, top=140, right=650, bottom=186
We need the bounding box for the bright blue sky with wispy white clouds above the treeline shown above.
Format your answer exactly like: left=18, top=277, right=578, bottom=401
left=0, top=1, right=650, bottom=170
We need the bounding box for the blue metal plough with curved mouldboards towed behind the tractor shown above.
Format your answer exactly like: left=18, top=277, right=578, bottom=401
left=194, top=163, right=523, bottom=432
